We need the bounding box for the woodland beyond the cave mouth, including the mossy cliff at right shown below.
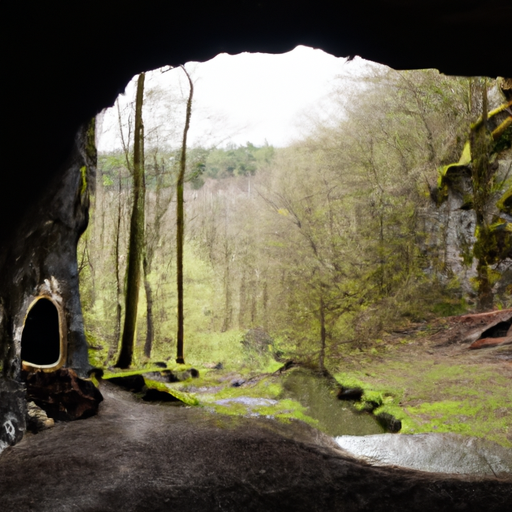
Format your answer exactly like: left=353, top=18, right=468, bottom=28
left=78, top=65, right=512, bottom=372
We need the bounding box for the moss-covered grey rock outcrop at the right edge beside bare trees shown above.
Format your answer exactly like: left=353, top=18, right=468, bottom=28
left=425, top=93, right=512, bottom=303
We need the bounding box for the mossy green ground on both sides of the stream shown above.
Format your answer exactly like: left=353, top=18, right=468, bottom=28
left=94, top=321, right=512, bottom=448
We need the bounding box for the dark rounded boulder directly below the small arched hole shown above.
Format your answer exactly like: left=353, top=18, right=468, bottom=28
left=26, top=368, right=103, bottom=421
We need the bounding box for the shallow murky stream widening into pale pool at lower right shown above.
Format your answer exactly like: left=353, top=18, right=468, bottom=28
left=213, top=369, right=512, bottom=479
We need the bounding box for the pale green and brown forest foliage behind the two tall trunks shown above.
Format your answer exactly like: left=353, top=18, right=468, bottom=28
left=81, top=70, right=501, bottom=392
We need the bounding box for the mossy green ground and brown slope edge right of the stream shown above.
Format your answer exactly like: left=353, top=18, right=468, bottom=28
left=335, top=324, right=512, bottom=448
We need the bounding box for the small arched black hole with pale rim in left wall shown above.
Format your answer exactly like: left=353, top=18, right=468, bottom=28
left=21, top=296, right=66, bottom=371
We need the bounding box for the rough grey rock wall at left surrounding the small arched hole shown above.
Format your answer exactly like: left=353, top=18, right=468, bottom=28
left=0, top=122, right=96, bottom=448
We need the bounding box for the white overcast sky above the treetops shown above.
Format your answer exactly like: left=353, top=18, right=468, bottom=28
left=98, top=46, right=365, bottom=151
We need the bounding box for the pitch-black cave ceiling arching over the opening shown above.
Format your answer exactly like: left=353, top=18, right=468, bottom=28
left=0, top=0, right=512, bottom=247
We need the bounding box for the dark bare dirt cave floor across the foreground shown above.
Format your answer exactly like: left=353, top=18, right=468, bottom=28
left=0, top=382, right=512, bottom=512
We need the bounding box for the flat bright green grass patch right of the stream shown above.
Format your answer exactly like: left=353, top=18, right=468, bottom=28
left=335, top=356, right=512, bottom=448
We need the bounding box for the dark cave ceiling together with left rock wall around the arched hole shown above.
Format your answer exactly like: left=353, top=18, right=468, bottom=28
left=0, top=0, right=512, bottom=448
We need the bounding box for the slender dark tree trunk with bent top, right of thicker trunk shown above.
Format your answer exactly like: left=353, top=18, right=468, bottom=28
left=176, top=66, right=194, bottom=364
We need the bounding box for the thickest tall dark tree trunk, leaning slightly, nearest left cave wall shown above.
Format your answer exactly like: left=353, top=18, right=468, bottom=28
left=116, top=73, right=146, bottom=368
